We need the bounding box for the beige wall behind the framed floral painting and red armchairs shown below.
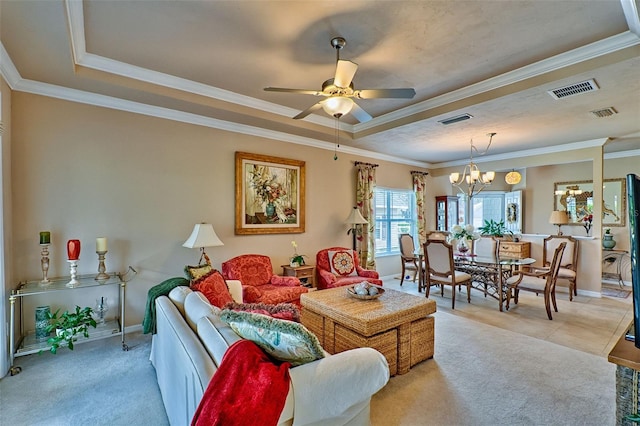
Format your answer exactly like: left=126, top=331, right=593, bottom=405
left=12, top=93, right=415, bottom=325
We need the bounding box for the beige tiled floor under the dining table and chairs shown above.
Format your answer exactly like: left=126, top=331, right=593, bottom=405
left=383, top=276, right=633, bottom=357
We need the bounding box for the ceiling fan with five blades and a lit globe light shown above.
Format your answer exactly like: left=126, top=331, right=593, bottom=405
left=264, top=37, right=416, bottom=123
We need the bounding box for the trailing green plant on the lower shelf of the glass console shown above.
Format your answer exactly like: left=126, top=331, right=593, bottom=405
left=47, top=306, right=97, bottom=354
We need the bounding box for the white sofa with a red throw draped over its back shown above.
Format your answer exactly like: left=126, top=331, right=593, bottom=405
left=151, top=281, right=389, bottom=426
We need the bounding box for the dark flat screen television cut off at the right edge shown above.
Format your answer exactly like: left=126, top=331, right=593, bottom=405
left=627, top=174, right=640, bottom=349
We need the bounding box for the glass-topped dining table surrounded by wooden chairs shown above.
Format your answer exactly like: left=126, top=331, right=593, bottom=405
left=418, top=253, right=536, bottom=312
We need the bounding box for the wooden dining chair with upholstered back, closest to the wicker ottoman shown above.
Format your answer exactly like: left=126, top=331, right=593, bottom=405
left=423, top=240, right=471, bottom=309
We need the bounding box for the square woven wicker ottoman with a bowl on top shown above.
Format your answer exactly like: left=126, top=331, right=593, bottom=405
left=300, top=287, right=436, bottom=375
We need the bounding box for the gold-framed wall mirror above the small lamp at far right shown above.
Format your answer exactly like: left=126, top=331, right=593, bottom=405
left=553, top=178, right=627, bottom=227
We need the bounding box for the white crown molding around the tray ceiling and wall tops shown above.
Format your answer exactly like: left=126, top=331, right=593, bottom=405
left=0, top=0, right=640, bottom=169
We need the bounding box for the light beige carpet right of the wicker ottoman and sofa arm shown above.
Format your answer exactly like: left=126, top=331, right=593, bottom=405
left=371, top=312, right=615, bottom=426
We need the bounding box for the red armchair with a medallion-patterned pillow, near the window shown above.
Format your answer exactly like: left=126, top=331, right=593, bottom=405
left=316, top=247, right=382, bottom=289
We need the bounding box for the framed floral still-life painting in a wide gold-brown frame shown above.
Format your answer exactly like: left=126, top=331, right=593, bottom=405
left=235, top=152, right=305, bottom=234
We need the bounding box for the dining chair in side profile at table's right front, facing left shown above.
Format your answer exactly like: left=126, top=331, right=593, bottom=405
left=506, top=242, right=567, bottom=320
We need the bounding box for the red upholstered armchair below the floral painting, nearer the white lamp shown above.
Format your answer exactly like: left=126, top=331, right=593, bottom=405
left=222, top=254, right=308, bottom=306
